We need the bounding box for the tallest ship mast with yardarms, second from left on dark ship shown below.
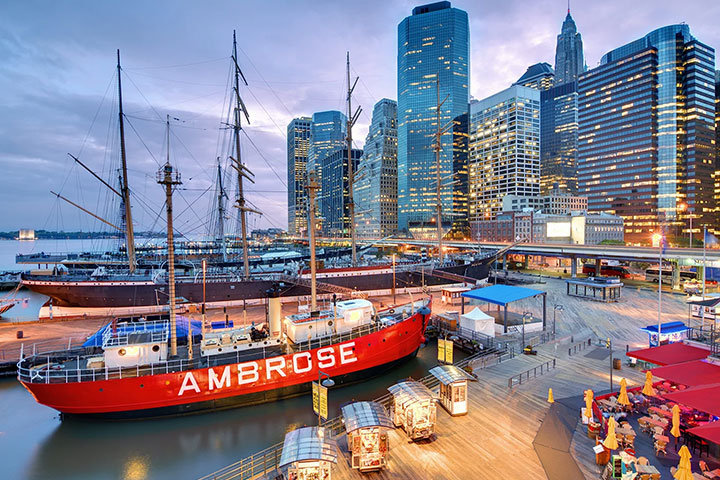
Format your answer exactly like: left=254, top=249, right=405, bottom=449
left=230, top=30, right=261, bottom=278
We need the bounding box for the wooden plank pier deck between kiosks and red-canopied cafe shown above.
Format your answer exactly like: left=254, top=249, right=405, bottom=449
left=326, top=279, right=687, bottom=480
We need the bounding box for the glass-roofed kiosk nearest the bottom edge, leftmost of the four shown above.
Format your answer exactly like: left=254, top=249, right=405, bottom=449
left=278, top=427, right=337, bottom=480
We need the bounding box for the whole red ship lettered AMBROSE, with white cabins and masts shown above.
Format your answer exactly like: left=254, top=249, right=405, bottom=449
left=18, top=41, right=431, bottom=418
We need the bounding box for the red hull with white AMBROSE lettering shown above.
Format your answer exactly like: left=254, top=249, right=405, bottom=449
left=18, top=311, right=429, bottom=418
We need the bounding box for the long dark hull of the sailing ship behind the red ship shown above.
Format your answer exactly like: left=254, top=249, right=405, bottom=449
left=23, top=265, right=488, bottom=309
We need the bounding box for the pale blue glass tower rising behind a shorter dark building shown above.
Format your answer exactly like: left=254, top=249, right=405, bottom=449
left=307, top=110, right=347, bottom=221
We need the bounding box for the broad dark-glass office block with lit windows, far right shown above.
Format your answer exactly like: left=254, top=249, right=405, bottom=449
left=578, top=25, right=716, bottom=243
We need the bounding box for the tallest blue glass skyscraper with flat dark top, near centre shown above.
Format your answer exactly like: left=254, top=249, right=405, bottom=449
left=398, top=2, right=470, bottom=231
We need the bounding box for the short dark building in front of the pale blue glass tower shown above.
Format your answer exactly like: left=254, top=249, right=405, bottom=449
left=318, top=148, right=362, bottom=237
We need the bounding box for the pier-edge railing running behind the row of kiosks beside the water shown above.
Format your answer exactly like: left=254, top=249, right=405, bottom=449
left=200, top=349, right=513, bottom=480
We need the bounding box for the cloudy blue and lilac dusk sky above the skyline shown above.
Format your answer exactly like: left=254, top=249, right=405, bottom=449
left=0, top=0, right=720, bottom=237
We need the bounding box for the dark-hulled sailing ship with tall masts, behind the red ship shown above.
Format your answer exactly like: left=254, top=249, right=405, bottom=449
left=22, top=39, right=495, bottom=318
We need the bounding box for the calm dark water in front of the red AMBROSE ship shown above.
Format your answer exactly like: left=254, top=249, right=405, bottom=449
left=9, top=343, right=456, bottom=480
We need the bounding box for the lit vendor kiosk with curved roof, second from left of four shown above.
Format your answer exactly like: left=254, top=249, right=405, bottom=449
left=342, top=402, right=394, bottom=472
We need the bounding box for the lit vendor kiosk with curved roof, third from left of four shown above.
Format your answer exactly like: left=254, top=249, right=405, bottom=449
left=388, top=380, right=437, bottom=440
